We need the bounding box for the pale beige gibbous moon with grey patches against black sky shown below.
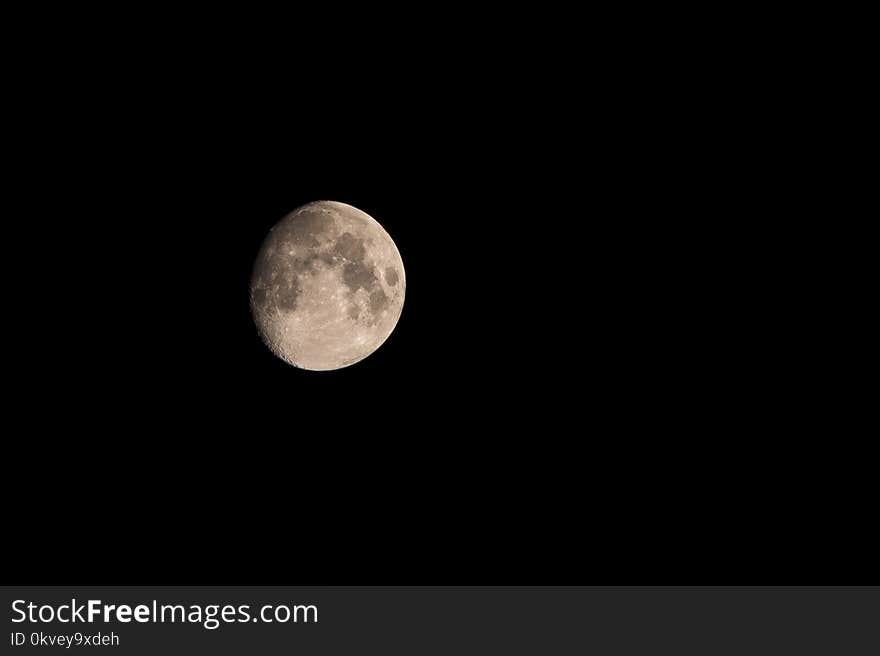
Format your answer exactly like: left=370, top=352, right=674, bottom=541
left=251, top=201, right=406, bottom=371
